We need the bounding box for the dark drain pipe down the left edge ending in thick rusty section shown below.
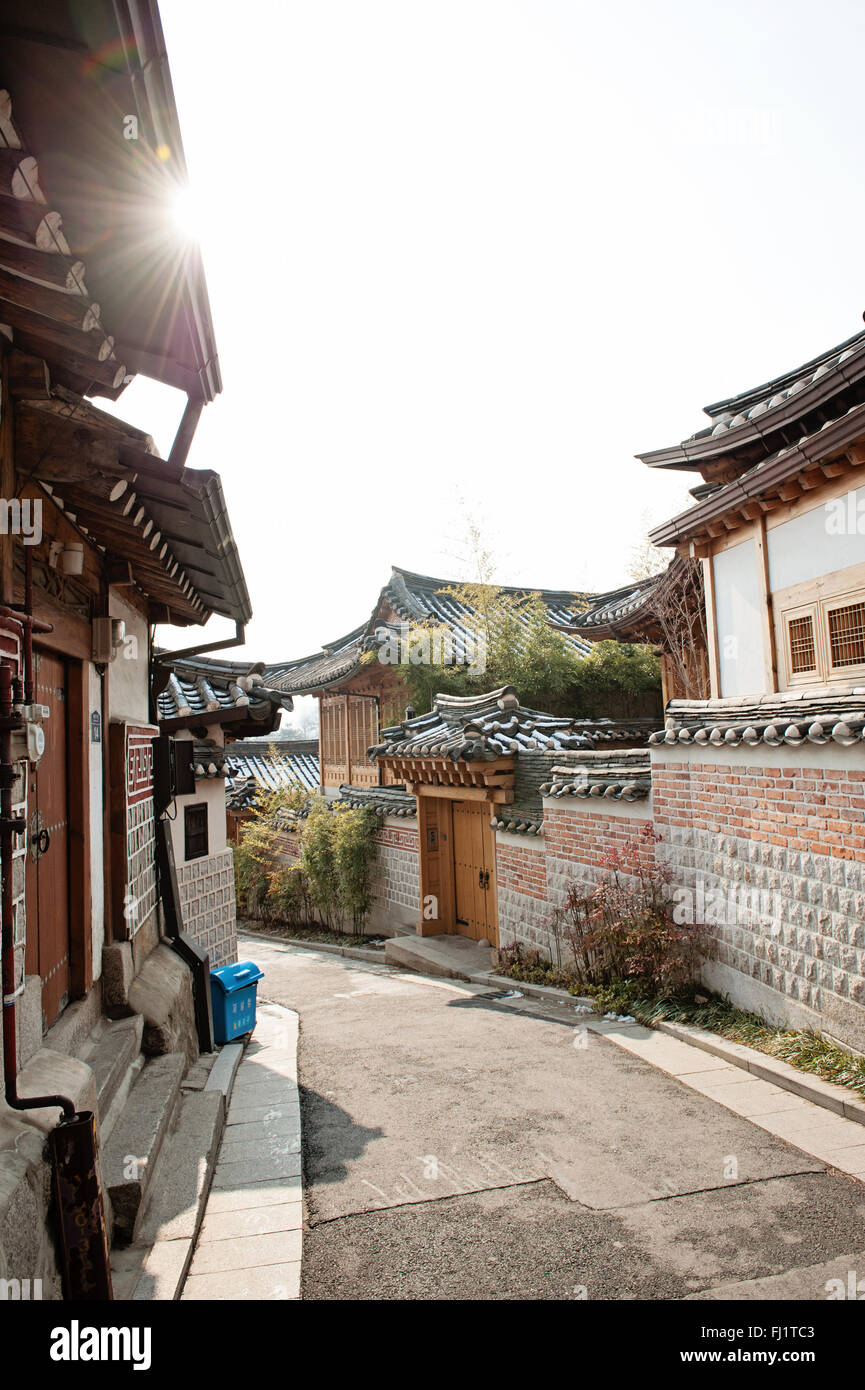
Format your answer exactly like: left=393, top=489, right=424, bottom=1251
left=0, top=636, right=113, bottom=1301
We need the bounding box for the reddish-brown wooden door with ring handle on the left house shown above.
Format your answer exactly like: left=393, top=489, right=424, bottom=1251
left=25, top=652, right=70, bottom=1029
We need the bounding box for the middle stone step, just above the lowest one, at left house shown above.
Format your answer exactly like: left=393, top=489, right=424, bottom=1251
left=103, top=1052, right=186, bottom=1245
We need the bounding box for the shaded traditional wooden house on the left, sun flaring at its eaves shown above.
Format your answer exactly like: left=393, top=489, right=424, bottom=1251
left=0, top=0, right=257, bottom=1298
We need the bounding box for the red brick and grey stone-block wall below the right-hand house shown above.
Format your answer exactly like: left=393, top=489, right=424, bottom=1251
left=652, top=746, right=865, bottom=1047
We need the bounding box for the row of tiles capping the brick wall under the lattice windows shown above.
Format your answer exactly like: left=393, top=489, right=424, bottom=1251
left=649, top=687, right=865, bottom=748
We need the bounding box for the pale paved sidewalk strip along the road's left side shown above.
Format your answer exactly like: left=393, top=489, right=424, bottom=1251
left=182, top=1004, right=303, bottom=1300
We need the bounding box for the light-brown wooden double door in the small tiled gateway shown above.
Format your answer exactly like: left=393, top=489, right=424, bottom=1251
left=419, top=794, right=498, bottom=945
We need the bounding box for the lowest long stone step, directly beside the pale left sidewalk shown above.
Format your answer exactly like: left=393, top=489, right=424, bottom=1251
left=127, top=1090, right=225, bottom=1302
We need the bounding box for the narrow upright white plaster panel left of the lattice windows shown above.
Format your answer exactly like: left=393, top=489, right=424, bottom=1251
left=712, top=539, right=766, bottom=696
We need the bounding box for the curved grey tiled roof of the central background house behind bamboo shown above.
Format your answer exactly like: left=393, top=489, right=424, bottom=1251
left=264, top=569, right=592, bottom=695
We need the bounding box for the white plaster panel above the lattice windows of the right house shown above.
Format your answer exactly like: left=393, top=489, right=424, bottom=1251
left=767, top=488, right=865, bottom=592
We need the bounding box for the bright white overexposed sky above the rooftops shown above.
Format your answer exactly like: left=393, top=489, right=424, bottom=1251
left=107, top=0, right=865, bottom=660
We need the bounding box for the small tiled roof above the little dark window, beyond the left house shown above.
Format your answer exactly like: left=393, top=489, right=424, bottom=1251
left=154, top=653, right=292, bottom=726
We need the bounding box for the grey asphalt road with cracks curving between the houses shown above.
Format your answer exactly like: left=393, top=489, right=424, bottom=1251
left=243, top=938, right=865, bottom=1300
